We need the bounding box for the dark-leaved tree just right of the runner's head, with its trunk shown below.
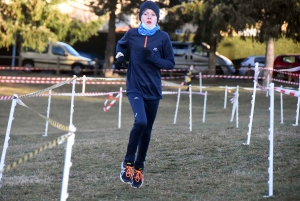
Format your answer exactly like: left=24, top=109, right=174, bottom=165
left=164, top=0, right=238, bottom=74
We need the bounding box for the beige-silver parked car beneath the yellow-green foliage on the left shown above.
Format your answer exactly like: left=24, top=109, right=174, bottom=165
left=20, top=42, right=95, bottom=75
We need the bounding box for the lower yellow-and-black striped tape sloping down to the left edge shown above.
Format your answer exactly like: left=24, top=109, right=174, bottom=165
left=0, top=133, right=73, bottom=173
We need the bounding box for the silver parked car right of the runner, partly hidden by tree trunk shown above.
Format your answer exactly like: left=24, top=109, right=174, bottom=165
left=172, top=41, right=235, bottom=75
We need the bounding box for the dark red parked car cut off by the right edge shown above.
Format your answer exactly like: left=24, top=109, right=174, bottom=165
left=273, top=54, right=300, bottom=80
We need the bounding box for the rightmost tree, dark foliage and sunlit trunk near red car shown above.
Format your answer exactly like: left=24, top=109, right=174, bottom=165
left=238, top=0, right=300, bottom=86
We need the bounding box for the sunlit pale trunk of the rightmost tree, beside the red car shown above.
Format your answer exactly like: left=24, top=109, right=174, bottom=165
left=263, top=38, right=275, bottom=87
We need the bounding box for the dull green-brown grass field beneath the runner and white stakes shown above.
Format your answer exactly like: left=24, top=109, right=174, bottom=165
left=0, top=74, right=300, bottom=201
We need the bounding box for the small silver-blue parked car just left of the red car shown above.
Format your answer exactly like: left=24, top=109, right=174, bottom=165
left=238, top=56, right=265, bottom=77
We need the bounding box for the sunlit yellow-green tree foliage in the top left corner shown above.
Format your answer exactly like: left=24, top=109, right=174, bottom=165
left=0, top=0, right=102, bottom=52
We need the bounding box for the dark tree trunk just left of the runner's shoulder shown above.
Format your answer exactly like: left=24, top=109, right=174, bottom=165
left=103, top=11, right=116, bottom=77
